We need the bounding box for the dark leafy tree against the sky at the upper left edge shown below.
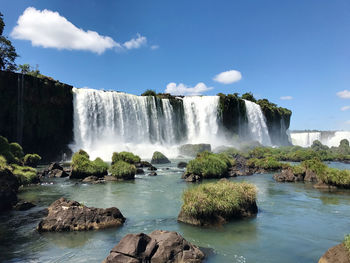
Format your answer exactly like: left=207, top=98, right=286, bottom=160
left=0, top=13, right=18, bottom=71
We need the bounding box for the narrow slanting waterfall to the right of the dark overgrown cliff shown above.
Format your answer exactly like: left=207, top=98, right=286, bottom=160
left=244, top=100, right=271, bottom=145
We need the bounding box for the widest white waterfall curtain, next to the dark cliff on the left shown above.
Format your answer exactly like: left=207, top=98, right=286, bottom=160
left=72, top=88, right=177, bottom=160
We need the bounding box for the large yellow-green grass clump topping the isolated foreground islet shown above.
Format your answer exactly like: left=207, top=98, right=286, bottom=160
left=182, top=181, right=257, bottom=221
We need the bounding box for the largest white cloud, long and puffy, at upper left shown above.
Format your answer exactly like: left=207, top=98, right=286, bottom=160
left=11, top=7, right=120, bottom=54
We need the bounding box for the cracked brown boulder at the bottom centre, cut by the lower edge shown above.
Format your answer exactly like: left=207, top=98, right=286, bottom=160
left=103, top=230, right=204, bottom=263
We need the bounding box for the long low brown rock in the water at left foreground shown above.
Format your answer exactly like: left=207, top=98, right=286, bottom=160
left=37, top=197, right=125, bottom=232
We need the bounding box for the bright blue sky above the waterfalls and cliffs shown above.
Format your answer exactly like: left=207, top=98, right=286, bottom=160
left=0, top=0, right=350, bottom=130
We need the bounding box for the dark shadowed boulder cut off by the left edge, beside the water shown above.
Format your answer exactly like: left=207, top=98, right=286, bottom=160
left=0, top=168, right=19, bottom=212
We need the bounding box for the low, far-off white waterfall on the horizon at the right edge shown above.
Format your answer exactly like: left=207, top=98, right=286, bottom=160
left=290, top=131, right=350, bottom=147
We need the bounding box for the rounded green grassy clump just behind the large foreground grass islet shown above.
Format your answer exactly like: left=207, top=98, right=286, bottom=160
left=186, top=152, right=231, bottom=178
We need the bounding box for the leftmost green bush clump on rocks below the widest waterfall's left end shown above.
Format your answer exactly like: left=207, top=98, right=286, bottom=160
left=72, top=150, right=108, bottom=178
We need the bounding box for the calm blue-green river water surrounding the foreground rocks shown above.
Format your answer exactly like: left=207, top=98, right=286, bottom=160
left=0, top=162, right=350, bottom=263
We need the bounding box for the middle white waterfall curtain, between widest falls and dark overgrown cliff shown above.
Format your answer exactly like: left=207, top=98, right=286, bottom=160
left=183, top=96, right=219, bottom=143
